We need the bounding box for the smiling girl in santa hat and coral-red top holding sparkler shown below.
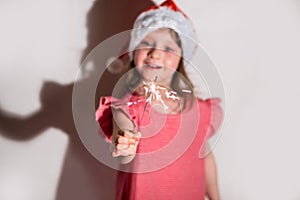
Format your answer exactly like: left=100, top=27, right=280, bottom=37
left=96, top=0, right=222, bottom=200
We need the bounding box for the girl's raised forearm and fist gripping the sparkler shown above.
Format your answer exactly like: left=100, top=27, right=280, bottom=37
left=112, top=111, right=140, bottom=164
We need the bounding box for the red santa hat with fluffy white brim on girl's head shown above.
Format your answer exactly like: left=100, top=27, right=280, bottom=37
left=129, top=0, right=197, bottom=64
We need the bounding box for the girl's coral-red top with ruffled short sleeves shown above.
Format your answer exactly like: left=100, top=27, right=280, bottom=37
left=96, top=95, right=222, bottom=200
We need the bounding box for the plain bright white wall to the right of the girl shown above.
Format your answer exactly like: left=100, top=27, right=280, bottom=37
left=185, top=0, right=300, bottom=200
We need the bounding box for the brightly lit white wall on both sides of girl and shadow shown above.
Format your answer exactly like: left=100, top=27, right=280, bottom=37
left=0, top=0, right=300, bottom=200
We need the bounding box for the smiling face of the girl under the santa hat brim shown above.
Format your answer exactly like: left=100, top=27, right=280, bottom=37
left=134, top=28, right=182, bottom=85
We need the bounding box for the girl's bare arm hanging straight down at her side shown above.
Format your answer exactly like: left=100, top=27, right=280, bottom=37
left=205, top=152, right=220, bottom=200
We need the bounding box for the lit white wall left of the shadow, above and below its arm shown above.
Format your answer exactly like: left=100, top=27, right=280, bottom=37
left=0, top=0, right=92, bottom=200
